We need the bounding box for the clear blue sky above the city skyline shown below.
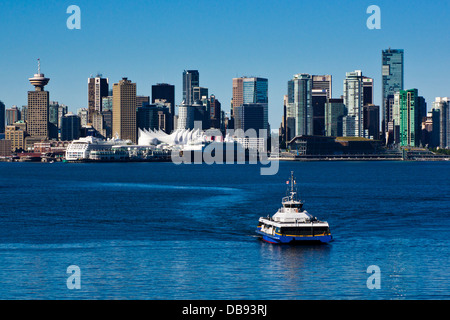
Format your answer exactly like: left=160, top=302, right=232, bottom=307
left=0, top=0, right=450, bottom=129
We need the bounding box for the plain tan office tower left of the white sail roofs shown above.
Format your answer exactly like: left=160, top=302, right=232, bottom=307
left=113, top=78, right=137, bottom=143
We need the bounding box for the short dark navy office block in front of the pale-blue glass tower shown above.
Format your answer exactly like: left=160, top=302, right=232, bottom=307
left=234, top=103, right=265, bottom=138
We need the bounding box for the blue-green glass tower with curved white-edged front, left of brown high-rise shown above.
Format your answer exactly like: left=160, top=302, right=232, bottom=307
left=286, top=74, right=314, bottom=136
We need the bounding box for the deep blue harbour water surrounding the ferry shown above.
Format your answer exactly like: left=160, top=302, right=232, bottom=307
left=0, top=162, right=450, bottom=300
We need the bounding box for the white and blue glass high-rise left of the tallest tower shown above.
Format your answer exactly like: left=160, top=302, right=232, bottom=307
left=343, top=70, right=365, bottom=137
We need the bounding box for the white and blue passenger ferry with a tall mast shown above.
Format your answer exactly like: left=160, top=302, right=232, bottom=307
left=256, top=172, right=333, bottom=244
